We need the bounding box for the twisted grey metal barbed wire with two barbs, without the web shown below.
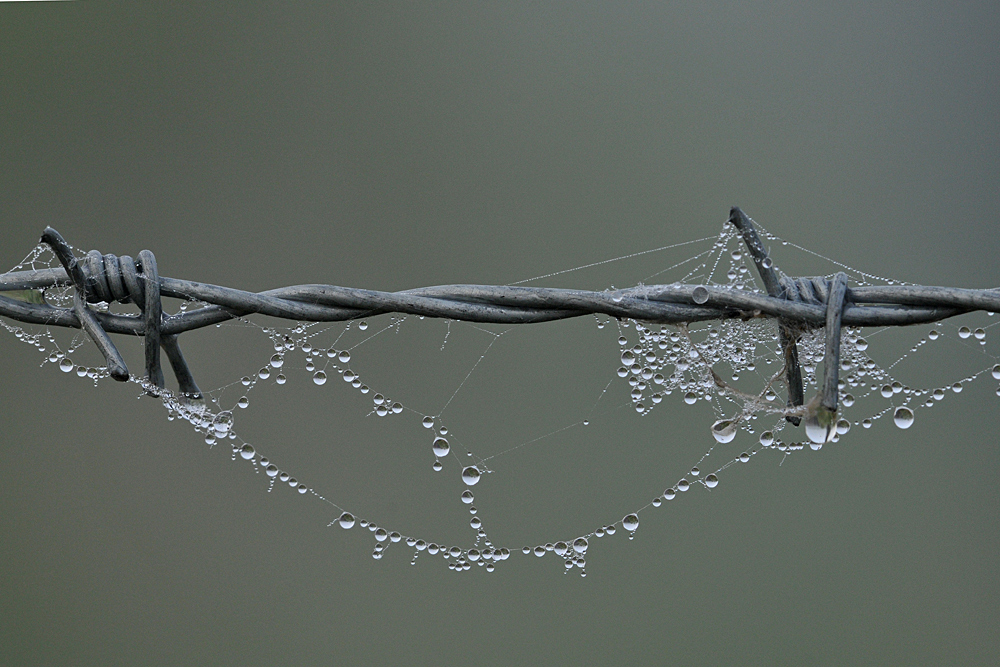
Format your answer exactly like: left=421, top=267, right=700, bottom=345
left=0, top=207, right=1000, bottom=438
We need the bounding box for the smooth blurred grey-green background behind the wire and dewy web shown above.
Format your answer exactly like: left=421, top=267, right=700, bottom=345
left=0, top=2, right=1000, bottom=665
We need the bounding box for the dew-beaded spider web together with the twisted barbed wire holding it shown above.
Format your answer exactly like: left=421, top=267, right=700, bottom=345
left=0, top=208, right=1000, bottom=573
